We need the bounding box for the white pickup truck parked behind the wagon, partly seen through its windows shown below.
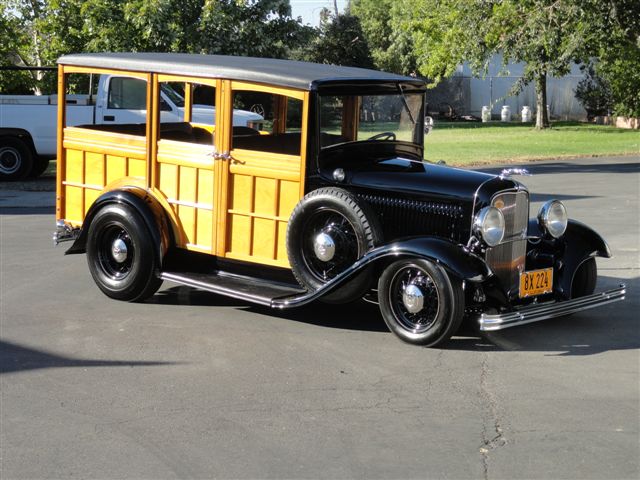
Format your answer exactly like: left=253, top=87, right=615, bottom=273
left=0, top=75, right=264, bottom=181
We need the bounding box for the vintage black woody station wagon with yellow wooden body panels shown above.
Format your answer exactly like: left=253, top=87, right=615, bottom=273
left=55, top=53, right=625, bottom=346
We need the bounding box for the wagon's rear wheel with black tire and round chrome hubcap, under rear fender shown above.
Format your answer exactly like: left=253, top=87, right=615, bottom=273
left=87, top=204, right=162, bottom=302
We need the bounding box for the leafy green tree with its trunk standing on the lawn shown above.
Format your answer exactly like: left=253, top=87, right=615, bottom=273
left=407, top=0, right=604, bottom=129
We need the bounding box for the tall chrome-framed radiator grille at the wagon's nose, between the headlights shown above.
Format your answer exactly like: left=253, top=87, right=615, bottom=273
left=486, top=191, right=529, bottom=293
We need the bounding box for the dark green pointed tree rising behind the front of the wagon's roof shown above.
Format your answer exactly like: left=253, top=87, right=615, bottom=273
left=295, top=12, right=373, bottom=68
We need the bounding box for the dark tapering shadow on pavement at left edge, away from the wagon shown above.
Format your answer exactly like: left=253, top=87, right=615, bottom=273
left=0, top=340, right=176, bottom=375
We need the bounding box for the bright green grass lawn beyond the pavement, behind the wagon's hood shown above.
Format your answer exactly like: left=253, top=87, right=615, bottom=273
left=425, top=121, right=640, bottom=165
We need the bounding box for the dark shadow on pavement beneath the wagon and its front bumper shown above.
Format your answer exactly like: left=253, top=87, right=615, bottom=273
left=147, top=276, right=640, bottom=356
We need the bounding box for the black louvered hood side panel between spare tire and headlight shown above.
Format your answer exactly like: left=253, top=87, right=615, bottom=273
left=360, top=194, right=469, bottom=242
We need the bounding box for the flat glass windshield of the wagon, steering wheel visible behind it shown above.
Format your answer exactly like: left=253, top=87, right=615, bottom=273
left=320, top=93, right=424, bottom=148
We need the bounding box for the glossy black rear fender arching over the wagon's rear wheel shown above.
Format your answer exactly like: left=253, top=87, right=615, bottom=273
left=65, top=187, right=174, bottom=265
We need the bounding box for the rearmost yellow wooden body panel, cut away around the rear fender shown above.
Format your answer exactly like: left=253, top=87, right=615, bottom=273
left=59, top=127, right=147, bottom=226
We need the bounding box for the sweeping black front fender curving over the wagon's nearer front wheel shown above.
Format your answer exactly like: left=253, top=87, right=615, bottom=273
left=271, top=237, right=491, bottom=308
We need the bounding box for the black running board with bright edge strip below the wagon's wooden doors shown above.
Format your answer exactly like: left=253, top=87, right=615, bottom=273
left=160, top=271, right=307, bottom=307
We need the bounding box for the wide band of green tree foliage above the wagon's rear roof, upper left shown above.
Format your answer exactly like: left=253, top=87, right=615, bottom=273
left=0, top=0, right=313, bottom=92
